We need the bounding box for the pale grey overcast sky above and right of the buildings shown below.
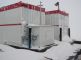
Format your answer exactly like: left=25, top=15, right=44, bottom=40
left=0, top=0, right=81, bottom=40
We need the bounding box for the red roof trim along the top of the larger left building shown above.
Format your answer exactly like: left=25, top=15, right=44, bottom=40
left=0, top=1, right=45, bottom=12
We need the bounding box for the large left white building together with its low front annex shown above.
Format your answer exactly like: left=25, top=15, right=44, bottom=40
left=0, top=2, right=54, bottom=48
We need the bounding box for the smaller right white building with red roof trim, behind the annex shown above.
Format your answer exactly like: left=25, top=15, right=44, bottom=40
left=45, top=10, right=70, bottom=41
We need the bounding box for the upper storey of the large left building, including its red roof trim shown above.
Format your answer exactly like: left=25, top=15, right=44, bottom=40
left=0, top=2, right=45, bottom=25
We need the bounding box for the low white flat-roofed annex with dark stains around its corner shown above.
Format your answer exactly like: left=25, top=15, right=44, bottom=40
left=22, top=25, right=54, bottom=48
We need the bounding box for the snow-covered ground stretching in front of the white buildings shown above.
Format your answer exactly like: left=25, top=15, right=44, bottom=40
left=0, top=36, right=81, bottom=60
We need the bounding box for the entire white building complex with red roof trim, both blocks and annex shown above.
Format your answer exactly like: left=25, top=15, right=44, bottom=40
left=0, top=2, right=70, bottom=48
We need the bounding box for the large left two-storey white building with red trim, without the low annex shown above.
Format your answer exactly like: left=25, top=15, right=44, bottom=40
left=0, top=2, right=45, bottom=46
